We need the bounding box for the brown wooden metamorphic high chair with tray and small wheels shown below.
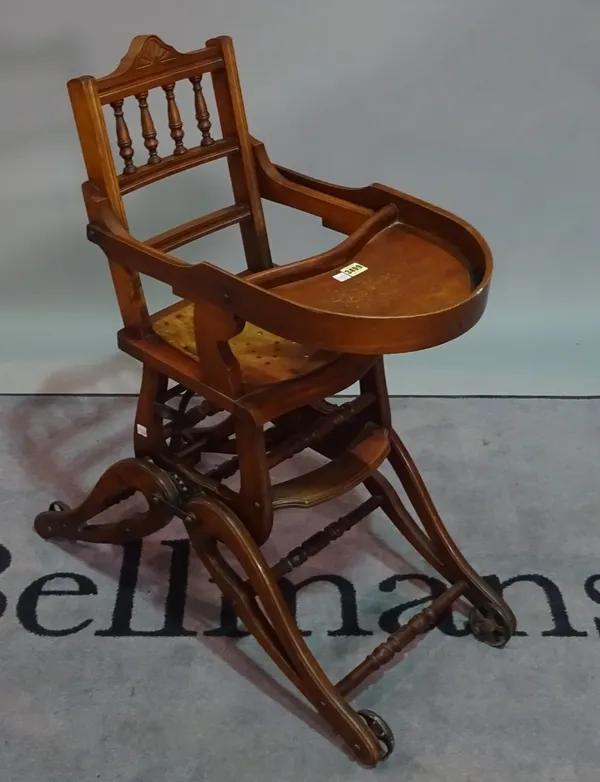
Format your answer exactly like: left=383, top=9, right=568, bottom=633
left=35, top=35, right=516, bottom=766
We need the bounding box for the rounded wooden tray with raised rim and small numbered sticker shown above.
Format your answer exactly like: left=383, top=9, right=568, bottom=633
left=180, top=199, right=492, bottom=355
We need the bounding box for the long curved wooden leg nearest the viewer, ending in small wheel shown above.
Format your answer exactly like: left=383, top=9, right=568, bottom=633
left=184, top=497, right=386, bottom=766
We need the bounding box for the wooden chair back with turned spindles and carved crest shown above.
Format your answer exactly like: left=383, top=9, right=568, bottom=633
left=67, top=35, right=272, bottom=326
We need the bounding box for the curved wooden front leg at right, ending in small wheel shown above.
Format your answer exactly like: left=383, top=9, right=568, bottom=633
left=366, top=431, right=517, bottom=647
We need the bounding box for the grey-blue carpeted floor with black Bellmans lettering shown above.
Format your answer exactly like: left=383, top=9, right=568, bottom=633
left=0, top=397, right=600, bottom=782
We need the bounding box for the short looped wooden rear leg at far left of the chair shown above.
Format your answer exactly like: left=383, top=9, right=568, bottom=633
left=34, top=459, right=179, bottom=544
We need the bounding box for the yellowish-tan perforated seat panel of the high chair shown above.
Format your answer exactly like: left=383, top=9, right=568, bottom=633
left=153, top=301, right=338, bottom=386
